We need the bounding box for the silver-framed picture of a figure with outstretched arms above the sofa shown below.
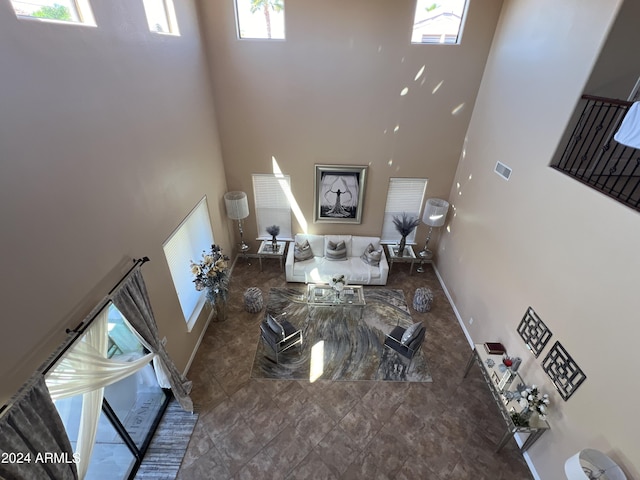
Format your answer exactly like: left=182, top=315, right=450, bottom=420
left=313, top=165, right=369, bottom=223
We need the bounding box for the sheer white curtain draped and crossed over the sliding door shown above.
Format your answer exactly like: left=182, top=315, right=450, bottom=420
left=46, top=306, right=155, bottom=479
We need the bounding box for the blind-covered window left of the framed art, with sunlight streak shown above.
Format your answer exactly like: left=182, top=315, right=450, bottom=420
left=251, top=173, right=293, bottom=240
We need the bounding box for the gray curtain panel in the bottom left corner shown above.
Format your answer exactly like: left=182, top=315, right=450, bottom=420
left=0, top=375, right=78, bottom=480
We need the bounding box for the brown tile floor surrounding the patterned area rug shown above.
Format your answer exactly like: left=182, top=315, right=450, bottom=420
left=177, top=259, right=528, bottom=480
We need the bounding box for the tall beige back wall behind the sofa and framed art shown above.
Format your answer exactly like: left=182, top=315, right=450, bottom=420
left=201, top=0, right=502, bottom=242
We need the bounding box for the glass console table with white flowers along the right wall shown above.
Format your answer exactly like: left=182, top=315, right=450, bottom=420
left=464, top=343, right=551, bottom=453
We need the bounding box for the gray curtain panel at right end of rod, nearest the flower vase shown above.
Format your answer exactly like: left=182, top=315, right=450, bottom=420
left=111, top=268, right=193, bottom=412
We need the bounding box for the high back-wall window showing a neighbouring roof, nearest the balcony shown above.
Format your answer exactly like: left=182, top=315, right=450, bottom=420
left=411, top=0, right=466, bottom=44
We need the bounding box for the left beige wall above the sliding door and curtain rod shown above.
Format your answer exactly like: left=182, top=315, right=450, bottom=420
left=0, top=0, right=230, bottom=403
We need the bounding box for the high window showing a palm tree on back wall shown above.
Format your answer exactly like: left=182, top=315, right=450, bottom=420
left=236, top=0, right=284, bottom=39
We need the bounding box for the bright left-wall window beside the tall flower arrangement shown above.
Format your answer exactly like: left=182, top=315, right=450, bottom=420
left=162, top=196, right=215, bottom=332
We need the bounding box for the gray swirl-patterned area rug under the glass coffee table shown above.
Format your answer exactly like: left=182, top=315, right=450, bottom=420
left=251, top=286, right=431, bottom=382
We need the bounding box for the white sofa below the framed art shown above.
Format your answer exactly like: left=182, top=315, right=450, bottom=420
left=285, top=234, right=389, bottom=285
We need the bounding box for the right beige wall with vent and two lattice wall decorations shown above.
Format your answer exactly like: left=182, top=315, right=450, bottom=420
left=438, top=0, right=640, bottom=479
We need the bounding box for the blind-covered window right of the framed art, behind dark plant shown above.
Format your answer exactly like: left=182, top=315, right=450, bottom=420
left=380, top=177, right=428, bottom=245
